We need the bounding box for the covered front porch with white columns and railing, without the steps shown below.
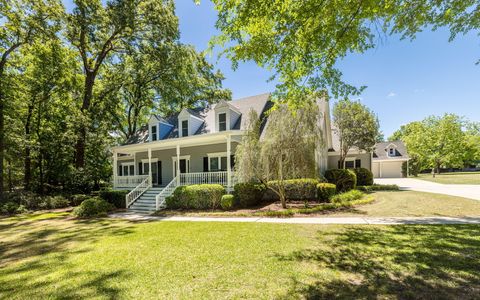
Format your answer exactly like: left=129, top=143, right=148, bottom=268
left=113, top=132, right=241, bottom=190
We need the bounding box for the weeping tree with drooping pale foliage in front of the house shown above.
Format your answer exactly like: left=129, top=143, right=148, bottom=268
left=236, top=101, right=324, bottom=208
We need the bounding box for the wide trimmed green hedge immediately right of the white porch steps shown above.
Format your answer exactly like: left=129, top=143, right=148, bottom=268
left=165, top=184, right=225, bottom=209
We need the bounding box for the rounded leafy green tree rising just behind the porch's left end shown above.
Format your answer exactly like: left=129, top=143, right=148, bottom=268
left=99, top=43, right=231, bottom=140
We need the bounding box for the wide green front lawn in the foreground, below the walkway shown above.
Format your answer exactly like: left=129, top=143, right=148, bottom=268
left=0, top=214, right=480, bottom=299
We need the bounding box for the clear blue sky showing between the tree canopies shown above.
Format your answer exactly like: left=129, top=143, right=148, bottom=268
left=67, top=0, right=480, bottom=137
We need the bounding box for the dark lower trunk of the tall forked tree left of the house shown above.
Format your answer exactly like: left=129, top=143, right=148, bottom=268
left=75, top=71, right=96, bottom=169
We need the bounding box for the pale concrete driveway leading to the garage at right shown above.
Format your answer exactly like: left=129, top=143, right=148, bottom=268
left=375, top=178, right=480, bottom=200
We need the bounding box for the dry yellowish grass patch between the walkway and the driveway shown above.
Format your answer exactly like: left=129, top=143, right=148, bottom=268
left=332, top=191, right=480, bottom=217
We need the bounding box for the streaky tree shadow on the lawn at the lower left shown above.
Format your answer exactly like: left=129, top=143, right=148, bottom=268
left=0, top=216, right=133, bottom=299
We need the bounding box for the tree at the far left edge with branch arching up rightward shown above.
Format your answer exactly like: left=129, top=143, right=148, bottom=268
left=0, top=0, right=63, bottom=200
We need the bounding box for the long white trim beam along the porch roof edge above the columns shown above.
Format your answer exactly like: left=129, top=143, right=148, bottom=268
left=112, top=130, right=244, bottom=154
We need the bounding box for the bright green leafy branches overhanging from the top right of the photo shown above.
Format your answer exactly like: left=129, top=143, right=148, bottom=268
left=212, top=0, right=480, bottom=104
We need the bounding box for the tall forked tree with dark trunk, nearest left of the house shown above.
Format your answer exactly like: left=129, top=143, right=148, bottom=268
left=67, top=0, right=179, bottom=168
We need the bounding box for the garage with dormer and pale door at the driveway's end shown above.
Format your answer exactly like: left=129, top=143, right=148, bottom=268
left=372, top=141, right=409, bottom=178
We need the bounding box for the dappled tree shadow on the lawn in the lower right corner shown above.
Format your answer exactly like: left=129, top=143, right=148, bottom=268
left=278, top=225, right=480, bottom=299
